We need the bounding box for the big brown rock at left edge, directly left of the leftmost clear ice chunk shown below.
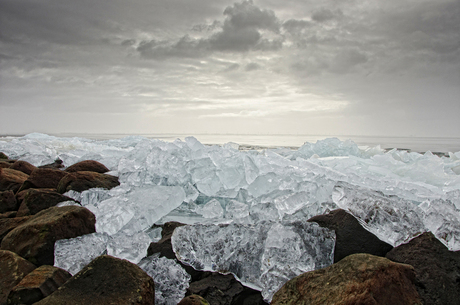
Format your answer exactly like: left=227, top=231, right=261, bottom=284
left=1, top=206, right=96, bottom=266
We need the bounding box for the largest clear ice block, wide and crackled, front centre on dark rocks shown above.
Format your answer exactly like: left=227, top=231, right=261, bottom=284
left=171, top=222, right=334, bottom=301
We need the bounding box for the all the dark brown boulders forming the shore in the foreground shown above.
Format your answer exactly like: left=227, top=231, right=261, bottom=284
left=0, top=153, right=460, bottom=305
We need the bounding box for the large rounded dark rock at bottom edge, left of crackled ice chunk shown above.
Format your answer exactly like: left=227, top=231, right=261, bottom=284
left=35, top=255, right=155, bottom=305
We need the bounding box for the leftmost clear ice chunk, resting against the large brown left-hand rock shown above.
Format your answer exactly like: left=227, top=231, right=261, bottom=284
left=54, top=233, right=110, bottom=275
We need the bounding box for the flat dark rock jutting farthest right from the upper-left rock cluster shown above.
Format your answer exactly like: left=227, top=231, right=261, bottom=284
left=57, top=172, right=120, bottom=194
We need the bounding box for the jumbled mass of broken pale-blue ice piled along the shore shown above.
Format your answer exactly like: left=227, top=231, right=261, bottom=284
left=0, top=134, right=460, bottom=299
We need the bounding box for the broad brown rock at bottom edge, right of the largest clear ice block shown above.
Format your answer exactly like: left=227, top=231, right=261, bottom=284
left=270, top=253, right=422, bottom=305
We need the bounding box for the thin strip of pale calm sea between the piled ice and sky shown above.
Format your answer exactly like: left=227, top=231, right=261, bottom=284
left=1, top=133, right=460, bottom=153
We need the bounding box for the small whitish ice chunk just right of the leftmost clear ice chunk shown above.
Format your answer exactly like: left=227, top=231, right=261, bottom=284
left=107, top=232, right=151, bottom=264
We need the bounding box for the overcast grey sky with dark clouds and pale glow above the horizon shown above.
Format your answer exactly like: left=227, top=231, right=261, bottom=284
left=0, top=0, right=460, bottom=137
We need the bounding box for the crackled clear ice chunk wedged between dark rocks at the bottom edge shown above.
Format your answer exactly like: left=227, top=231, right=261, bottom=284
left=138, top=253, right=191, bottom=305
